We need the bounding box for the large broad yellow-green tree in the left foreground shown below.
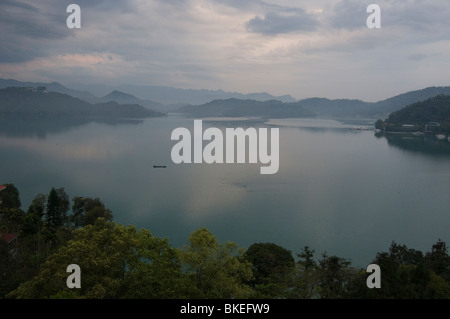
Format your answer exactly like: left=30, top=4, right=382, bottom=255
left=7, top=218, right=187, bottom=299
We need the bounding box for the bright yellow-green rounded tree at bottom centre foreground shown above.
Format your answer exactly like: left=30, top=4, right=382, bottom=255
left=179, top=228, right=252, bottom=298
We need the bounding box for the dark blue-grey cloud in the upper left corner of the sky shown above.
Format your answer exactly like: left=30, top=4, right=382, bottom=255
left=0, top=0, right=137, bottom=63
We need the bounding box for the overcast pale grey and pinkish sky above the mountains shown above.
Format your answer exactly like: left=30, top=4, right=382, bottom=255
left=0, top=0, right=450, bottom=101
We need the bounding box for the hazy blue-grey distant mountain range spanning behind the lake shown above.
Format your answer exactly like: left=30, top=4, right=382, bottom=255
left=0, top=79, right=450, bottom=119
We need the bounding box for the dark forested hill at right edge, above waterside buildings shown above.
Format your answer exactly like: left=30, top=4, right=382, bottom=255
left=378, top=95, right=450, bottom=133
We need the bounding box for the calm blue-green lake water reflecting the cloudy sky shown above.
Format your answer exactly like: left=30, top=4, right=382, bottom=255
left=0, top=114, right=450, bottom=267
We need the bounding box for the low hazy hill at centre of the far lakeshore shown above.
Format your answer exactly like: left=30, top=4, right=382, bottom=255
left=179, top=99, right=315, bottom=118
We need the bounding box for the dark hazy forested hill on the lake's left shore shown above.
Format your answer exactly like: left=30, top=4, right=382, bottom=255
left=0, top=87, right=164, bottom=118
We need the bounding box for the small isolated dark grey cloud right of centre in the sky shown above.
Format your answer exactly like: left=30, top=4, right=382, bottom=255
left=246, top=9, right=319, bottom=35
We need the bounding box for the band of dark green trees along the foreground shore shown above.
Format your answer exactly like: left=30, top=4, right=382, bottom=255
left=0, top=184, right=450, bottom=299
